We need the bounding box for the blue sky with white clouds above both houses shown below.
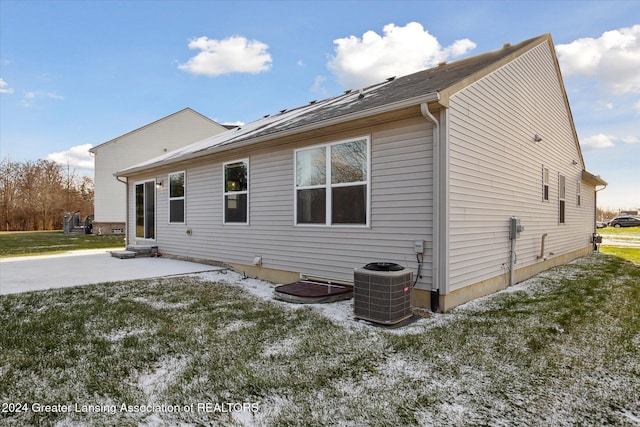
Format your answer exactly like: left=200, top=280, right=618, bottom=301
left=0, top=0, right=640, bottom=208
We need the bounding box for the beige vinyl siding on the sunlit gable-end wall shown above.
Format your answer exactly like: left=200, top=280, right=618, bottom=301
left=449, top=43, right=593, bottom=291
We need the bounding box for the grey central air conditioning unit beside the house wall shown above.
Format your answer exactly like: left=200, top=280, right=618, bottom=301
left=353, top=262, right=413, bottom=325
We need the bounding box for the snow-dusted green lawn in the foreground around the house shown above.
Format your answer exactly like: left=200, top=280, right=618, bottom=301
left=0, top=254, right=640, bottom=426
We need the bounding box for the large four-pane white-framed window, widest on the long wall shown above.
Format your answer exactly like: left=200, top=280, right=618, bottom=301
left=295, top=137, right=369, bottom=225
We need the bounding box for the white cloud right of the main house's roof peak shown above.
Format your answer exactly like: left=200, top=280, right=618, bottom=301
left=556, top=24, right=640, bottom=95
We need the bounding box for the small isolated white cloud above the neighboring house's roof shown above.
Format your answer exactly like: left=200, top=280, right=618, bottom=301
left=178, top=36, right=271, bottom=77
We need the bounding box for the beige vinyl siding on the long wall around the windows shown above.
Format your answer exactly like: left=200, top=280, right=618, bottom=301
left=130, top=117, right=432, bottom=284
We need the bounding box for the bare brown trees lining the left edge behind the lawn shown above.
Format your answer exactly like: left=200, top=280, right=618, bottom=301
left=0, top=158, right=93, bottom=231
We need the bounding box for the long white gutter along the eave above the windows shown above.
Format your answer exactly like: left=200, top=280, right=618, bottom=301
left=114, top=92, right=440, bottom=177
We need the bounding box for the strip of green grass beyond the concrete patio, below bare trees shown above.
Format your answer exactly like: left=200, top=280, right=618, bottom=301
left=0, top=231, right=124, bottom=258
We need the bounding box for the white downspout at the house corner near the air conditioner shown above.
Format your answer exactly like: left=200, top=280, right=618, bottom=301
left=420, top=102, right=440, bottom=312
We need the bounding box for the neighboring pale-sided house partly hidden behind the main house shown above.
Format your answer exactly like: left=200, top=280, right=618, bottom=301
left=89, top=108, right=228, bottom=234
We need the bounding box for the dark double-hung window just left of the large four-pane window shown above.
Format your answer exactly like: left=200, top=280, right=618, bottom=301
left=224, top=160, right=249, bottom=224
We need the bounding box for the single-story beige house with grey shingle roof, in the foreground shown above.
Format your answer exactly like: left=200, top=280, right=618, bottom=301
left=116, top=34, right=606, bottom=311
